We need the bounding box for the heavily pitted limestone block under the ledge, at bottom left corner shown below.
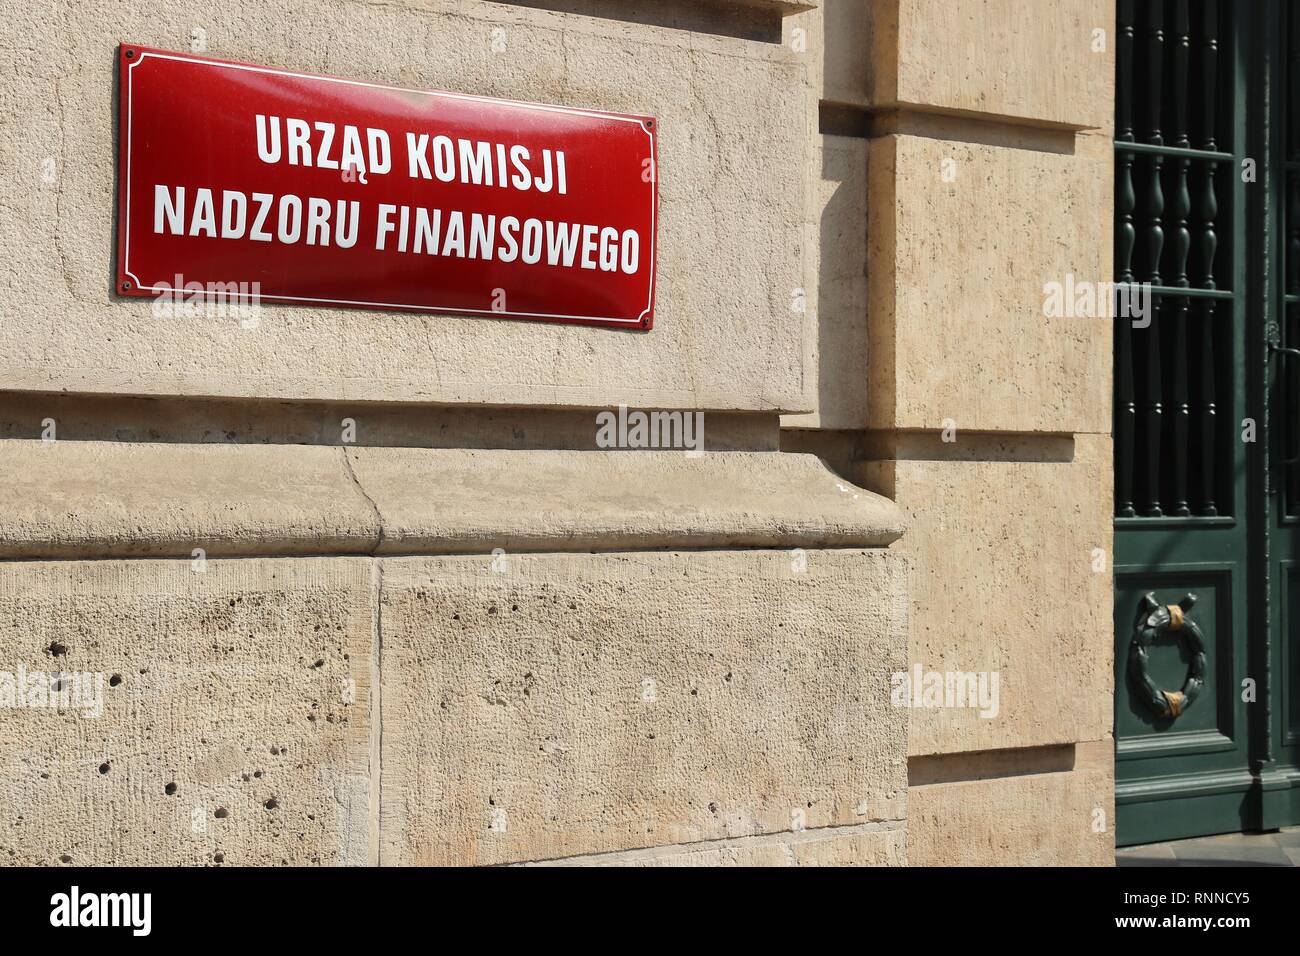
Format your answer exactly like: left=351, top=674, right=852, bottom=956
left=0, top=558, right=373, bottom=866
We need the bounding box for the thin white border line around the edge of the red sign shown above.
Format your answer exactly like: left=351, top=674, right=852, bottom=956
left=122, top=51, right=659, bottom=325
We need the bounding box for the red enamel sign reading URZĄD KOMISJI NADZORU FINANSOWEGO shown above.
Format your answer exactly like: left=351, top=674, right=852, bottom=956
left=117, top=46, right=658, bottom=329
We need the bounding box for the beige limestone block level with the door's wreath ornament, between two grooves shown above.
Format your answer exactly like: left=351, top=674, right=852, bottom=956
left=863, top=432, right=1114, bottom=754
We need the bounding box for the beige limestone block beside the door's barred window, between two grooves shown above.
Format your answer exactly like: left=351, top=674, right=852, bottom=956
left=867, top=135, right=1113, bottom=433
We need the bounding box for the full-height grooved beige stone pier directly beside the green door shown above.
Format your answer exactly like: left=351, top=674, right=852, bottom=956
left=783, top=0, right=1114, bottom=865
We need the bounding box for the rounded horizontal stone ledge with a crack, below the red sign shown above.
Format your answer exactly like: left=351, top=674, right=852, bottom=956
left=0, top=440, right=904, bottom=559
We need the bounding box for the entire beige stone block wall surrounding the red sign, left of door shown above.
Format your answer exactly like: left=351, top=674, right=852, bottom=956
left=0, top=0, right=1113, bottom=865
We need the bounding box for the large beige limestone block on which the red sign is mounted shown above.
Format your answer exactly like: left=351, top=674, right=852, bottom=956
left=0, top=0, right=815, bottom=411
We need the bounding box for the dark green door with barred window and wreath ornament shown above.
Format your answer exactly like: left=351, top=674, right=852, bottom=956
left=1114, top=0, right=1300, bottom=844
